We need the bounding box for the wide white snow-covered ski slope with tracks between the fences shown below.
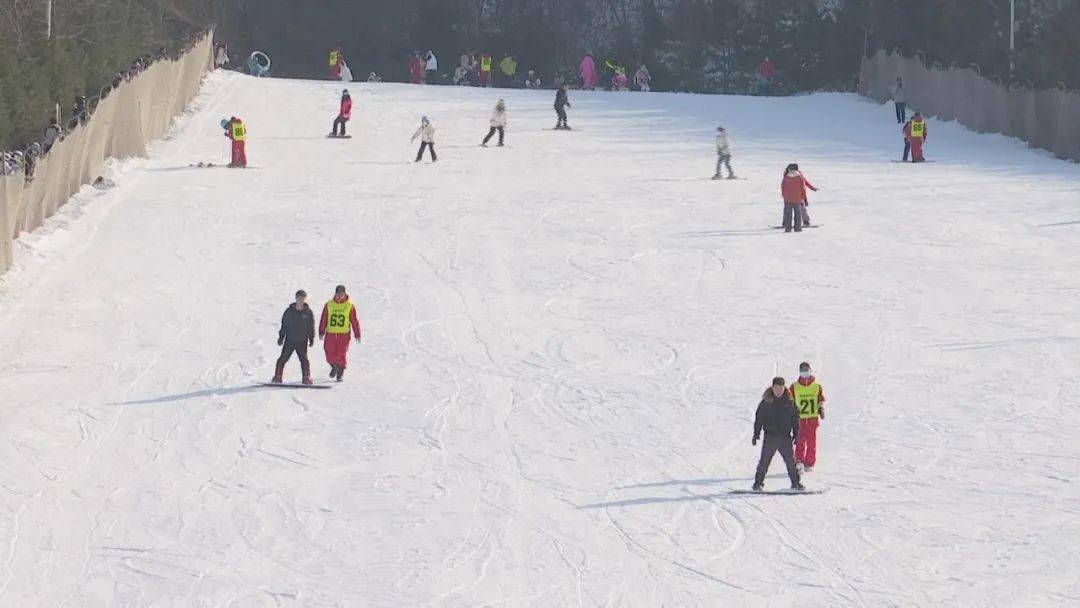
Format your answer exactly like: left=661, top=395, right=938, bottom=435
left=0, top=73, right=1080, bottom=607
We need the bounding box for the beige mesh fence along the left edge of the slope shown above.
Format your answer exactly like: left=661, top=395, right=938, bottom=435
left=0, top=32, right=214, bottom=273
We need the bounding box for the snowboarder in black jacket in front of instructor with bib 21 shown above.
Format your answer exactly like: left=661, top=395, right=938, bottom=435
left=752, top=378, right=806, bottom=491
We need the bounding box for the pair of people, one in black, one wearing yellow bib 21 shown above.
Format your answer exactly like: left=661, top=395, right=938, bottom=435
left=751, top=362, right=825, bottom=491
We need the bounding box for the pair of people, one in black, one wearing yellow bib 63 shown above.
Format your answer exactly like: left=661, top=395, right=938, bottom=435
left=271, top=285, right=361, bottom=386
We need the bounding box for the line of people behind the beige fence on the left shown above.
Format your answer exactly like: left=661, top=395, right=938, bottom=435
left=0, top=31, right=207, bottom=183
